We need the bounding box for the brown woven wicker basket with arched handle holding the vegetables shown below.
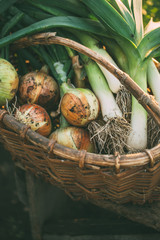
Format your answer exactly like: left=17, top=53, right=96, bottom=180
left=0, top=31, right=160, bottom=206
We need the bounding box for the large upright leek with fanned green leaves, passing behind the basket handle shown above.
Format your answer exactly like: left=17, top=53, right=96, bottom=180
left=78, top=0, right=160, bottom=151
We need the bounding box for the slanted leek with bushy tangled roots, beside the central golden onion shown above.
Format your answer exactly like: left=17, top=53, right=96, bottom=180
left=81, top=55, right=130, bottom=154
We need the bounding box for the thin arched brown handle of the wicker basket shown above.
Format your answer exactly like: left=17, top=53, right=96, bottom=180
left=12, top=32, right=160, bottom=126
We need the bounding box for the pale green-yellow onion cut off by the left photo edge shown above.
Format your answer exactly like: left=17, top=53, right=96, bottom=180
left=0, top=58, right=19, bottom=106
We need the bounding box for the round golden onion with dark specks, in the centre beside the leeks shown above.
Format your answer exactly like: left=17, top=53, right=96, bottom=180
left=61, top=88, right=100, bottom=126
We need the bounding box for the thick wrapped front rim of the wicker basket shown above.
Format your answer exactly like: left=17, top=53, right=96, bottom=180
left=0, top=109, right=160, bottom=172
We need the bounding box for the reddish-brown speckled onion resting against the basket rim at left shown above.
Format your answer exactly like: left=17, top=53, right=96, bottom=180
left=15, top=104, right=52, bottom=137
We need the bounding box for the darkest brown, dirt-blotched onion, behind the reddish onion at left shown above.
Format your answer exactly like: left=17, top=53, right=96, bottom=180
left=19, top=71, right=59, bottom=108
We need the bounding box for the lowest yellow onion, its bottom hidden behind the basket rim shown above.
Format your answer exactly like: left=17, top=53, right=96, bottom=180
left=49, top=126, right=94, bottom=152
